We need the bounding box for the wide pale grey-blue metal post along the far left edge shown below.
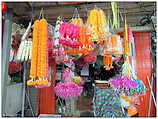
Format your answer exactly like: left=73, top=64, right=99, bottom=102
left=1, top=9, right=12, bottom=117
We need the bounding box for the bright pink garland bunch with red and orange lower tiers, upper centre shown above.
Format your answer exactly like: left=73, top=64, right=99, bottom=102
left=59, top=22, right=86, bottom=59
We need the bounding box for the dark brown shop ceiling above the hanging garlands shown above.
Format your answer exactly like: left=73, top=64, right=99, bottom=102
left=8, top=2, right=156, bottom=26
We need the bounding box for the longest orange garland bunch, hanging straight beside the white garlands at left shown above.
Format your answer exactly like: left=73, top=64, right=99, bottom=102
left=27, top=19, right=50, bottom=87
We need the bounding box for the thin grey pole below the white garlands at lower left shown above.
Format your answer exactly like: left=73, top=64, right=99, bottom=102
left=21, top=61, right=27, bottom=117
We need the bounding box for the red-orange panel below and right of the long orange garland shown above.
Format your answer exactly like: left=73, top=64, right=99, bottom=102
left=38, top=59, right=56, bottom=114
